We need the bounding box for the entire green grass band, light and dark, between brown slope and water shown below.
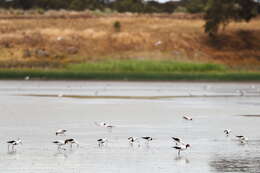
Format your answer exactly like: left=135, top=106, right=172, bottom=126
left=0, top=60, right=260, bottom=81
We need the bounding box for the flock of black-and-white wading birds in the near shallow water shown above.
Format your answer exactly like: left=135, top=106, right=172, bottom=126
left=7, top=116, right=248, bottom=156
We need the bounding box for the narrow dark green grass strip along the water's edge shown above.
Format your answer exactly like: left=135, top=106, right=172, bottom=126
left=0, top=70, right=260, bottom=82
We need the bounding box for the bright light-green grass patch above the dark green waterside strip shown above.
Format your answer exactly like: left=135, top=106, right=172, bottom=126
left=67, top=60, right=227, bottom=73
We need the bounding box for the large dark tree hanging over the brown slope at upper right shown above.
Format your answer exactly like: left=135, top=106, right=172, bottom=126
left=204, top=0, right=257, bottom=36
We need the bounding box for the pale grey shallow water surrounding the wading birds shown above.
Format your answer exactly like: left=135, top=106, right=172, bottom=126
left=0, top=81, right=260, bottom=173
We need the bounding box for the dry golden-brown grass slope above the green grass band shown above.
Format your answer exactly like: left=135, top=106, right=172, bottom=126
left=0, top=12, right=260, bottom=69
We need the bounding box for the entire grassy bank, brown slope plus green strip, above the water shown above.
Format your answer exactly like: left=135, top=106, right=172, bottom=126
left=0, top=11, right=260, bottom=81
